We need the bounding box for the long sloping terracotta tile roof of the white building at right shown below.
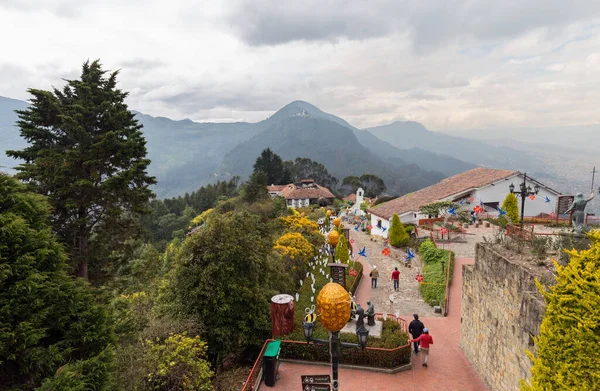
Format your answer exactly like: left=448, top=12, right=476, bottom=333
left=368, top=167, right=518, bottom=219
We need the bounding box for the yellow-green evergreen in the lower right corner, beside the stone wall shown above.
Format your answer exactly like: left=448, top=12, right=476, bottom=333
left=521, top=230, right=600, bottom=391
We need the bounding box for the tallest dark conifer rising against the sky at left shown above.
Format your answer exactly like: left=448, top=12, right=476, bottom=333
left=8, top=60, right=155, bottom=278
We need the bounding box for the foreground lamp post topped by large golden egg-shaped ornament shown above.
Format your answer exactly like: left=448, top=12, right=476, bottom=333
left=303, top=282, right=369, bottom=391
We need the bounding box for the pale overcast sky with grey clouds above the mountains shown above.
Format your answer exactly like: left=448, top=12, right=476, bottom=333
left=0, top=0, right=600, bottom=130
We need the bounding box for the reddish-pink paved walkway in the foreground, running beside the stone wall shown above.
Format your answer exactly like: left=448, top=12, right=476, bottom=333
left=261, top=256, right=487, bottom=391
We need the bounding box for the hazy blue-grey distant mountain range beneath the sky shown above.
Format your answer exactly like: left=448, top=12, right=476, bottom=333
left=0, top=97, right=596, bottom=207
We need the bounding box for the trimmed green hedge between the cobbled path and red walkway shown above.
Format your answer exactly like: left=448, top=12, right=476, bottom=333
left=419, top=240, right=454, bottom=306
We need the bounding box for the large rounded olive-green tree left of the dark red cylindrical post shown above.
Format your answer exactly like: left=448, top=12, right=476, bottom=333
left=165, top=212, right=291, bottom=363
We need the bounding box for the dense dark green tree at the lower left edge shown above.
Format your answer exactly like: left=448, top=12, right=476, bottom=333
left=0, top=174, right=113, bottom=390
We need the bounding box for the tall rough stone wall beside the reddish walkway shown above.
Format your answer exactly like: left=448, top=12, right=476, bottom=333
left=460, top=243, right=545, bottom=391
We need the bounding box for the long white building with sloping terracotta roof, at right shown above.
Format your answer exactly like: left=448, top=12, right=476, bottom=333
left=368, top=167, right=560, bottom=235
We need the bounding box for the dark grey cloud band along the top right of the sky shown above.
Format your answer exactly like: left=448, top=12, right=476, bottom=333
left=225, top=0, right=600, bottom=52
